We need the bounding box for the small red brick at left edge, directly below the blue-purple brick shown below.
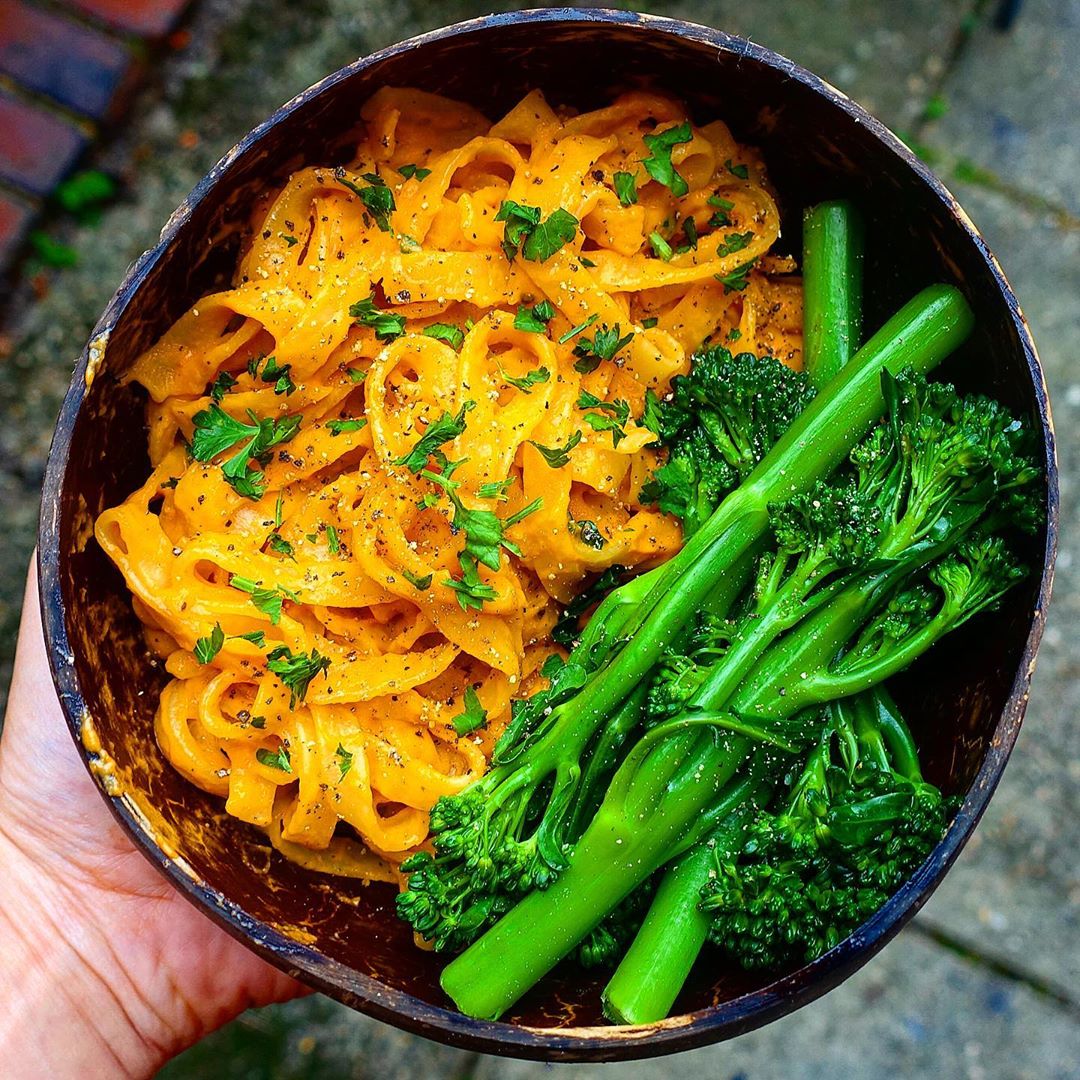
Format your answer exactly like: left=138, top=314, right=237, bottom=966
left=0, top=92, right=86, bottom=195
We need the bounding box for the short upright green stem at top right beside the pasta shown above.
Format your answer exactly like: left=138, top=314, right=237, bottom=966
left=802, top=200, right=863, bottom=390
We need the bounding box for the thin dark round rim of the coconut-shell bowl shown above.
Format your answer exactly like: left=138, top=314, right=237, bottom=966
left=38, top=8, right=1058, bottom=1062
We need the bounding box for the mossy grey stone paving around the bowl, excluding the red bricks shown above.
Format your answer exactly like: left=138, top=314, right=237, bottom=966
left=0, top=0, right=1080, bottom=1080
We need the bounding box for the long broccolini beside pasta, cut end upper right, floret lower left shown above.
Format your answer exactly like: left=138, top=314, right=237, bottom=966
left=399, top=286, right=971, bottom=989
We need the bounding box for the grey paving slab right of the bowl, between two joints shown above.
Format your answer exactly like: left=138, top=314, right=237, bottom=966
left=898, top=181, right=1080, bottom=996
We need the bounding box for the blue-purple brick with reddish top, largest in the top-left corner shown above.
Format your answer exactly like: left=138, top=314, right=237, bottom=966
left=0, top=0, right=132, bottom=119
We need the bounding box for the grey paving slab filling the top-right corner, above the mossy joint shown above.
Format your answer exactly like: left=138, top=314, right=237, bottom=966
left=927, top=0, right=1080, bottom=214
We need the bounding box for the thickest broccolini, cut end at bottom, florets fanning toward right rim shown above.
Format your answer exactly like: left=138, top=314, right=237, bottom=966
left=443, top=356, right=1038, bottom=1018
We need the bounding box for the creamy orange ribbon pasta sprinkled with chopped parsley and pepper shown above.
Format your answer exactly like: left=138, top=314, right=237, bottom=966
left=96, top=89, right=801, bottom=880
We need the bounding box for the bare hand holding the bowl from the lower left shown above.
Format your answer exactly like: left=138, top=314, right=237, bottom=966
left=0, top=568, right=305, bottom=1080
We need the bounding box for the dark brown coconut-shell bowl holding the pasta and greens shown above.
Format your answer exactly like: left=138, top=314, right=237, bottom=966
left=40, top=9, right=1057, bottom=1061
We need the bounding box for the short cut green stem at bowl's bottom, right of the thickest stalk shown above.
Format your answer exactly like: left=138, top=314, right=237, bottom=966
left=604, top=806, right=750, bottom=1024
